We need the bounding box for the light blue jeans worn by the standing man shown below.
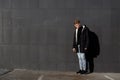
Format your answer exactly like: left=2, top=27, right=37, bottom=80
left=77, top=45, right=86, bottom=70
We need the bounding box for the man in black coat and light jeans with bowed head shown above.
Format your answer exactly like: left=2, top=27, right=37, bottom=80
left=72, top=20, right=89, bottom=74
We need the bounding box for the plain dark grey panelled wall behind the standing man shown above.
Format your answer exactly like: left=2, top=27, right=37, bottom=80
left=0, top=0, right=120, bottom=72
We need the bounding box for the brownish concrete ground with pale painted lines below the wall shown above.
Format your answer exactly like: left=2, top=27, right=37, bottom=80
left=0, top=69, right=120, bottom=80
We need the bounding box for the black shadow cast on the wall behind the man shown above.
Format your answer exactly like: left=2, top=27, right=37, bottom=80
left=86, top=31, right=100, bottom=73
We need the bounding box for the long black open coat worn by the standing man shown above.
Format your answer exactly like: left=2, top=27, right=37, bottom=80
left=73, top=26, right=89, bottom=53
